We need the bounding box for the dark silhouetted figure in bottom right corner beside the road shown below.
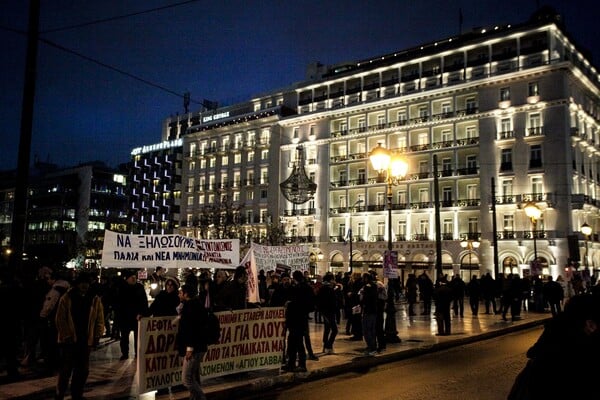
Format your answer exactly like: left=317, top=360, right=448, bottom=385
left=508, top=294, right=600, bottom=400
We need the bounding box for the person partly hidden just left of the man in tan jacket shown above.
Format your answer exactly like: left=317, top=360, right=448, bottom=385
left=40, top=271, right=71, bottom=373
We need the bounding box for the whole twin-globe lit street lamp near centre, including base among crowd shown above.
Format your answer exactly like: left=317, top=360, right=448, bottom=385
left=369, top=143, right=408, bottom=343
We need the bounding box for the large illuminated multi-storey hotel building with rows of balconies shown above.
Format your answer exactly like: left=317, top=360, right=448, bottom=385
left=163, top=9, right=600, bottom=280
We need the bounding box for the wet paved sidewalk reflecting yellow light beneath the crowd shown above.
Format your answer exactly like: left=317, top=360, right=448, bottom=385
left=0, top=304, right=551, bottom=400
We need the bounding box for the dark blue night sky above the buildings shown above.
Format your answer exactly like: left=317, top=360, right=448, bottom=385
left=0, top=0, right=600, bottom=170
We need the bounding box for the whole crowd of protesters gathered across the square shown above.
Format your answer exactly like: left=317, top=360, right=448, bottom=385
left=0, top=260, right=600, bottom=399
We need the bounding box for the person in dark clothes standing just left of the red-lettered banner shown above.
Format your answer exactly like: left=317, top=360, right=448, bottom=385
left=116, top=270, right=148, bottom=361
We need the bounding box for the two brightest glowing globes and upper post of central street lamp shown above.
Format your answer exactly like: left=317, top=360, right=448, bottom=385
left=369, top=143, right=408, bottom=252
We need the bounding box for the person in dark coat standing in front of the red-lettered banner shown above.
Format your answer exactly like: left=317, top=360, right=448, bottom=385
left=176, top=284, right=208, bottom=400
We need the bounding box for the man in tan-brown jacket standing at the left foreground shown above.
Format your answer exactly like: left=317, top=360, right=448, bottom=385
left=55, top=272, right=104, bottom=400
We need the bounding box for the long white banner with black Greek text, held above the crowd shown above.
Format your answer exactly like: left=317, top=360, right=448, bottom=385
left=102, top=230, right=240, bottom=269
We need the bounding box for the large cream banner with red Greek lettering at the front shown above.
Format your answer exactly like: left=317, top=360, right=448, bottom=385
left=137, top=307, right=285, bottom=394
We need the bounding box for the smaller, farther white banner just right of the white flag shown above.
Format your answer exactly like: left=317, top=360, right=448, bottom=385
left=251, top=243, right=309, bottom=271
